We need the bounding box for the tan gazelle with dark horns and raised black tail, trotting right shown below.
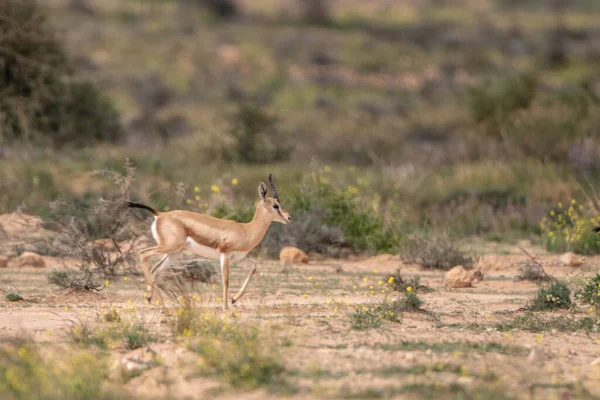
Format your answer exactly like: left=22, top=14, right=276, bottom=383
left=127, top=174, right=292, bottom=310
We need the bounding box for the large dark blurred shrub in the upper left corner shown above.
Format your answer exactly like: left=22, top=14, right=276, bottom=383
left=0, top=0, right=123, bottom=147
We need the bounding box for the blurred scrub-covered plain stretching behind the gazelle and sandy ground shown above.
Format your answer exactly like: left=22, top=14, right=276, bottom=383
left=0, top=0, right=600, bottom=256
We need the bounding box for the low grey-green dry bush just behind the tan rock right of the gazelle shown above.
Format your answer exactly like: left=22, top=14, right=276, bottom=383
left=403, top=232, right=475, bottom=270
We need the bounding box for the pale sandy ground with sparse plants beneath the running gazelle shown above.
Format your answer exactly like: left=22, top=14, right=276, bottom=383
left=0, top=242, right=600, bottom=399
